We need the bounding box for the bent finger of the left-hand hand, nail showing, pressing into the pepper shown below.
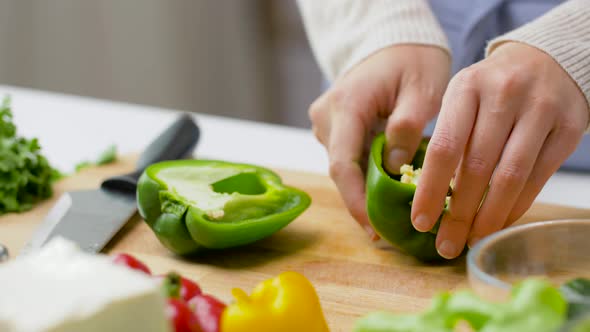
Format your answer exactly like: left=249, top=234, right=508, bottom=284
left=385, top=88, right=441, bottom=174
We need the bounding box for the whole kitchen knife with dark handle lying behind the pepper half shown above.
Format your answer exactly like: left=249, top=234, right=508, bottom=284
left=19, top=114, right=200, bottom=256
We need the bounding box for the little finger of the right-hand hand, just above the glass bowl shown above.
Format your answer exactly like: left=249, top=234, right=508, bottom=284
left=504, top=123, right=581, bottom=227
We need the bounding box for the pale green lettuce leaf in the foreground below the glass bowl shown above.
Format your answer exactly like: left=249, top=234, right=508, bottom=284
left=354, top=279, right=567, bottom=332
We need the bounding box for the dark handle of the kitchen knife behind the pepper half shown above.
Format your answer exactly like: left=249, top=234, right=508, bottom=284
left=101, top=114, right=200, bottom=194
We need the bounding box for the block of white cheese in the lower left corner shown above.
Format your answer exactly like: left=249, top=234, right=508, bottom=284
left=0, top=238, right=170, bottom=332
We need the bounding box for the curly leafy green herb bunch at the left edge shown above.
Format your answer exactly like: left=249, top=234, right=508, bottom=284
left=0, top=97, right=59, bottom=214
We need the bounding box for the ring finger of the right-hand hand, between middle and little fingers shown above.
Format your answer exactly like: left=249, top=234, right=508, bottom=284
left=469, top=112, right=553, bottom=246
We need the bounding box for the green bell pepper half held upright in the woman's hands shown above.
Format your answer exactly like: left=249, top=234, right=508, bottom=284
left=366, top=134, right=460, bottom=261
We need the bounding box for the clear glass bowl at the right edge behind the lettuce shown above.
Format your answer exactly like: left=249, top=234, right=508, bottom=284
left=467, top=219, right=590, bottom=301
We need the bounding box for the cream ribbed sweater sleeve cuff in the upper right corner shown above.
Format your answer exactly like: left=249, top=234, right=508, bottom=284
left=486, top=0, right=590, bottom=122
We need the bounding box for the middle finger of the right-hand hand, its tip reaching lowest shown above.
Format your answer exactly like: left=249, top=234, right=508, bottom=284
left=436, top=97, right=515, bottom=259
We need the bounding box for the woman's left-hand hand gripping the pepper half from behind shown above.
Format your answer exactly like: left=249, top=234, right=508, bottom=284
left=309, top=45, right=450, bottom=239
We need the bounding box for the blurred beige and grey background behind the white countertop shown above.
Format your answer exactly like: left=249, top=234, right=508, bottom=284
left=0, top=0, right=322, bottom=127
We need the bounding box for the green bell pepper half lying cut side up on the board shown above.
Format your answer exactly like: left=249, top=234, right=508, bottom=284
left=137, top=160, right=311, bottom=255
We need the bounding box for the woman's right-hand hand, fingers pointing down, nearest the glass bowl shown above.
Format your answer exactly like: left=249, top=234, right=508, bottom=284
left=412, top=42, right=588, bottom=258
